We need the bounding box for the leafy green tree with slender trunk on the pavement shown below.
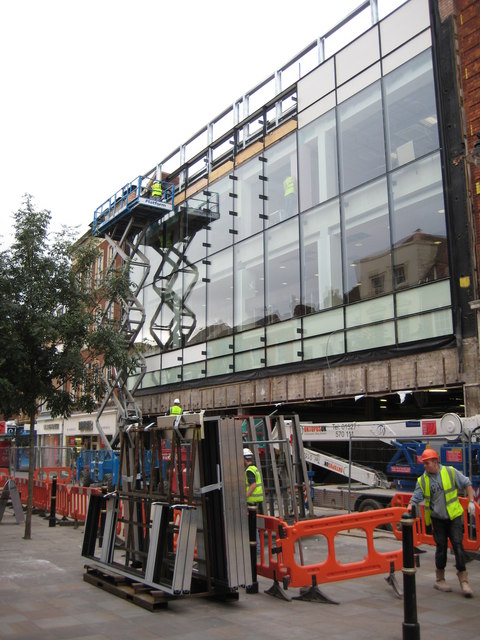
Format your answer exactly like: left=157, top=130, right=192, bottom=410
left=0, top=194, right=136, bottom=540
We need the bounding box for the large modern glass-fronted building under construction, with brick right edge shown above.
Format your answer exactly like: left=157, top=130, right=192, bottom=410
left=94, top=0, right=480, bottom=430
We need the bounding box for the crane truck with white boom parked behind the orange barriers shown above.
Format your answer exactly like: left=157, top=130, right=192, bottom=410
left=299, top=413, right=480, bottom=511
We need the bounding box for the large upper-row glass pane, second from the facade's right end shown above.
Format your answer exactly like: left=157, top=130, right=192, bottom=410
left=338, top=82, right=385, bottom=191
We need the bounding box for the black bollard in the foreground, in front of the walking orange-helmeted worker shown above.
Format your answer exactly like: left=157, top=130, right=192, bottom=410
left=401, top=512, right=420, bottom=640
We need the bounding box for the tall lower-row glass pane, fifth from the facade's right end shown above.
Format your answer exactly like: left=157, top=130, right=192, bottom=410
left=234, top=234, right=265, bottom=331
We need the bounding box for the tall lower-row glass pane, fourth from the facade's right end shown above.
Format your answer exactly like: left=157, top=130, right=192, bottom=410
left=265, top=218, right=300, bottom=324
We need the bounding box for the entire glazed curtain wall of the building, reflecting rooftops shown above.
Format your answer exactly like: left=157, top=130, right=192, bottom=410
left=137, top=38, right=452, bottom=386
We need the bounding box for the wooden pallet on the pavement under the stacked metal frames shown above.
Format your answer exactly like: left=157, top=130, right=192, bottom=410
left=83, top=565, right=169, bottom=611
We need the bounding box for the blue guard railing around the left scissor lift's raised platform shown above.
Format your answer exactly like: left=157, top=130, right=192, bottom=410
left=92, top=176, right=175, bottom=235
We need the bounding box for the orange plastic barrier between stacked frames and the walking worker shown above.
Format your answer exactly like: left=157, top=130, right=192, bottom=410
left=257, top=507, right=417, bottom=587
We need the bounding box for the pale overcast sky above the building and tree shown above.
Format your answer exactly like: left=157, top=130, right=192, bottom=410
left=0, top=0, right=390, bottom=248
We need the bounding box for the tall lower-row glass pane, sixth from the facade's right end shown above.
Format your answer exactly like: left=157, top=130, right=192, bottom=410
left=206, top=248, right=233, bottom=339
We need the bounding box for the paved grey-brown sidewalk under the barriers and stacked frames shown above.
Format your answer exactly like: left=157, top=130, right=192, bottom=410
left=0, top=507, right=480, bottom=640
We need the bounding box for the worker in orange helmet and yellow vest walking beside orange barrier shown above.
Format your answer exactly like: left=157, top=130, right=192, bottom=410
left=408, top=448, right=475, bottom=598
